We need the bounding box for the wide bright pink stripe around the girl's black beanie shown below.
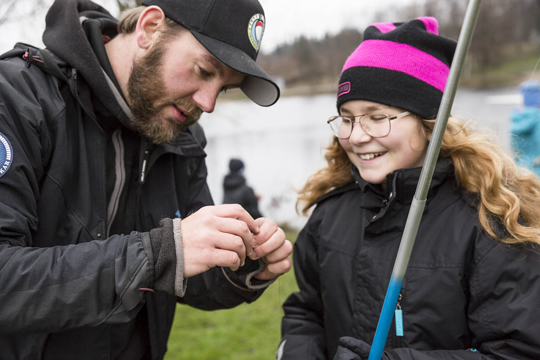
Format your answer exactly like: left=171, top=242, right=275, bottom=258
left=342, top=40, right=450, bottom=91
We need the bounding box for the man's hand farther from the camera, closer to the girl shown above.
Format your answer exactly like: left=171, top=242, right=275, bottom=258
left=250, top=218, right=293, bottom=280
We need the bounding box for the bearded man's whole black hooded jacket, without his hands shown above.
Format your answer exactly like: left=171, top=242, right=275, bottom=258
left=0, top=0, right=264, bottom=360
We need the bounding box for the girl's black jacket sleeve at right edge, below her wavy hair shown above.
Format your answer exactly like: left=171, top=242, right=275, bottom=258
left=378, top=235, right=540, bottom=360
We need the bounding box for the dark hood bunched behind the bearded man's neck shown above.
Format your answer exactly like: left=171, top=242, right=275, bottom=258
left=43, top=0, right=130, bottom=126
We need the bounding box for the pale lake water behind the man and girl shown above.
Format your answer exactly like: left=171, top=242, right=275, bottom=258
left=201, top=88, right=520, bottom=228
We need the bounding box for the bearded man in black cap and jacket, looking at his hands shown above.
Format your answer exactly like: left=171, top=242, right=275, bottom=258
left=0, top=0, right=292, bottom=360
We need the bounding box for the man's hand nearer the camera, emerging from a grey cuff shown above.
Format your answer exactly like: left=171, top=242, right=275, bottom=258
left=180, top=204, right=259, bottom=278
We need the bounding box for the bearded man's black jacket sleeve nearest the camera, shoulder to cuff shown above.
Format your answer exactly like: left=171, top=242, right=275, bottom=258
left=0, top=61, right=156, bottom=334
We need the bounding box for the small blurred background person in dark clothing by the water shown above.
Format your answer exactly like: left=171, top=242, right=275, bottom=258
left=223, top=159, right=262, bottom=219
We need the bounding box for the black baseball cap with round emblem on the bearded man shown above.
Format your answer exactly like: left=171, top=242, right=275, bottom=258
left=142, top=0, right=279, bottom=106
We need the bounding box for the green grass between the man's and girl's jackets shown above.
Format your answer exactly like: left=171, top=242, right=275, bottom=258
left=165, top=234, right=297, bottom=360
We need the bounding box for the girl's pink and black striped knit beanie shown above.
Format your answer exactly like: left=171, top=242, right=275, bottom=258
left=337, top=17, right=456, bottom=119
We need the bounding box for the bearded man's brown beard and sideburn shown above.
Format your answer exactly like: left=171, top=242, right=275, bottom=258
left=128, top=39, right=202, bottom=144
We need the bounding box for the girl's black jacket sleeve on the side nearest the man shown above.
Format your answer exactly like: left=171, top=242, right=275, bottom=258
left=277, top=209, right=327, bottom=360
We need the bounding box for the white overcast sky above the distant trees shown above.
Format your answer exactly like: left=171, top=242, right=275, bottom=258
left=0, top=0, right=423, bottom=52
